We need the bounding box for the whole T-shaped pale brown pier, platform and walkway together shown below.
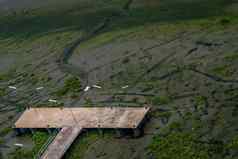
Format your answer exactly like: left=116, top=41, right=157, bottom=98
left=15, top=107, right=149, bottom=159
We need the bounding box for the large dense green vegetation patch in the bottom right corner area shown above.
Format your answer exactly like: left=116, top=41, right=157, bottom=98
left=149, top=132, right=222, bottom=159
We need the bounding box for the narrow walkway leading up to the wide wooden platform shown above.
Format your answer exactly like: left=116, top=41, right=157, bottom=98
left=41, top=127, right=82, bottom=159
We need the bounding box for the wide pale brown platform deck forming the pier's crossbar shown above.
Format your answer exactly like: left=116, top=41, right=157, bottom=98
left=15, top=107, right=149, bottom=128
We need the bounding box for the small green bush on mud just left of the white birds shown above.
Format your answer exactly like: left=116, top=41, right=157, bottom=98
left=56, top=77, right=81, bottom=97
